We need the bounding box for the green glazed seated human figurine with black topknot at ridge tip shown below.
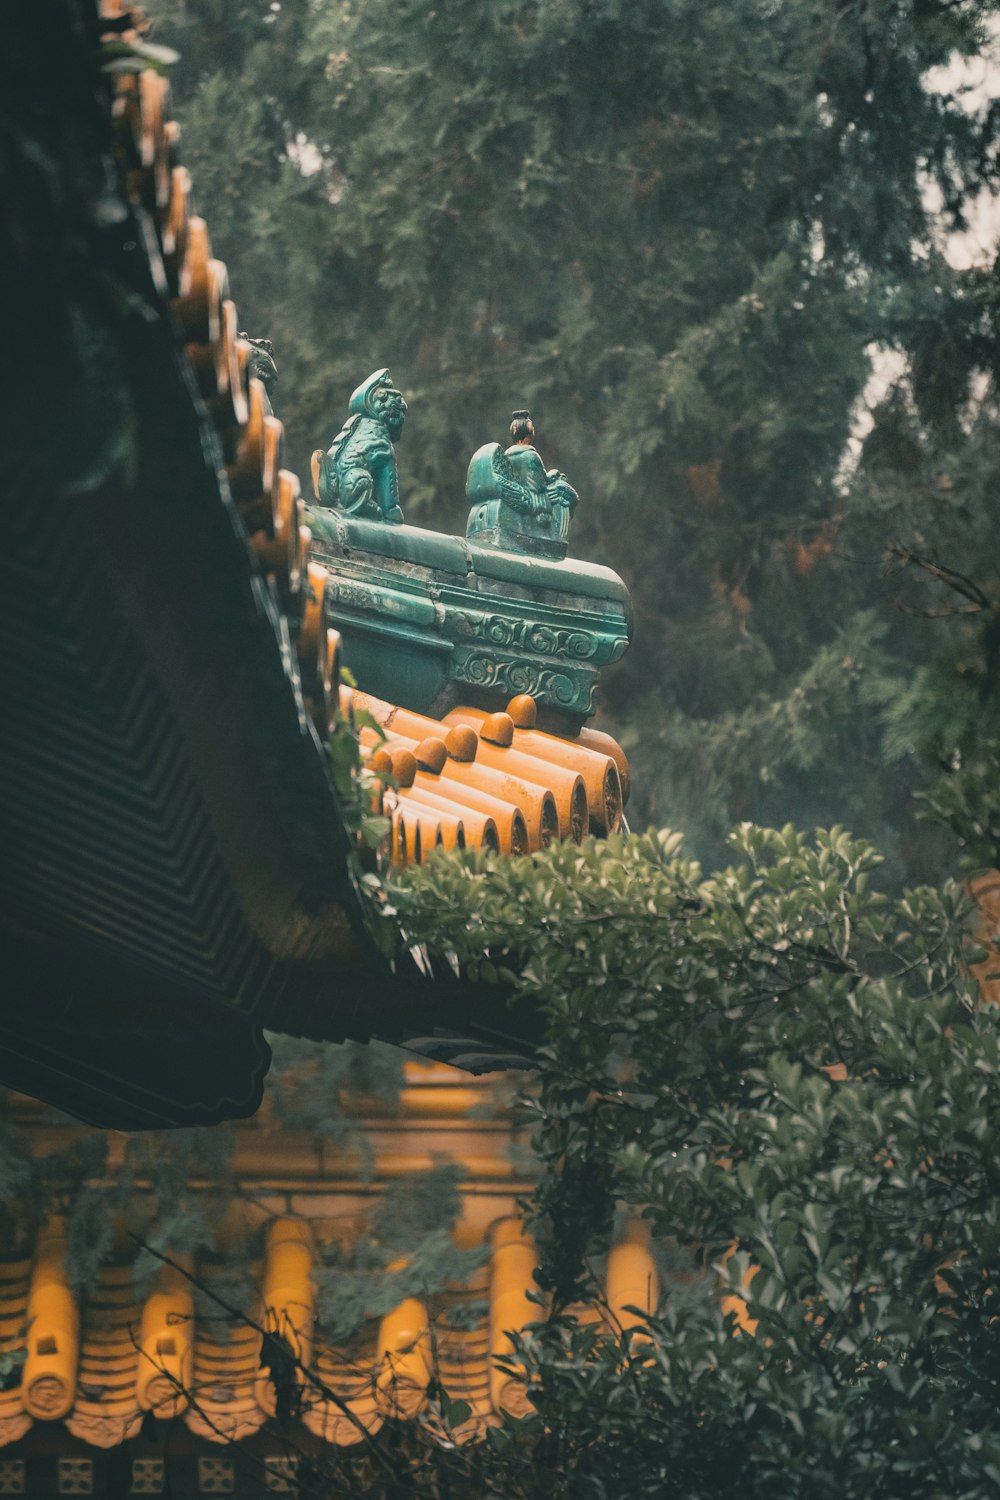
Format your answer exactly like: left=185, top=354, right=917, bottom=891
left=465, top=411, right=580, bottom=558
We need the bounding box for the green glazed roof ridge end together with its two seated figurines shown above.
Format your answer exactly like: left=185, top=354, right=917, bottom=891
left=306, top=381, right=631, bottom=735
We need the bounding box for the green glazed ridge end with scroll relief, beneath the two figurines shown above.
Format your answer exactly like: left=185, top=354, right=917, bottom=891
left=306, top=507, right=631, bottom=735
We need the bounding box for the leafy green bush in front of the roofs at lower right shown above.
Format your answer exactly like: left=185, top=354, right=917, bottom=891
left=393, top=810, right=1000, bottom=1500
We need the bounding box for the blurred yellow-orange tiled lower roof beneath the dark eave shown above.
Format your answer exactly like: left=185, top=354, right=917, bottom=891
left=0, top=1062, right=658, bottom=1470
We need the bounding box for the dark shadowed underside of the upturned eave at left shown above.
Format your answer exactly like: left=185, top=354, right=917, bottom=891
left=0, top=0, right=536, bottom=1128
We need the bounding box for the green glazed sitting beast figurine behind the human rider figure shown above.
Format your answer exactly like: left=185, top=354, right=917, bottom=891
left=312, top=369, right=406, bottom=527
